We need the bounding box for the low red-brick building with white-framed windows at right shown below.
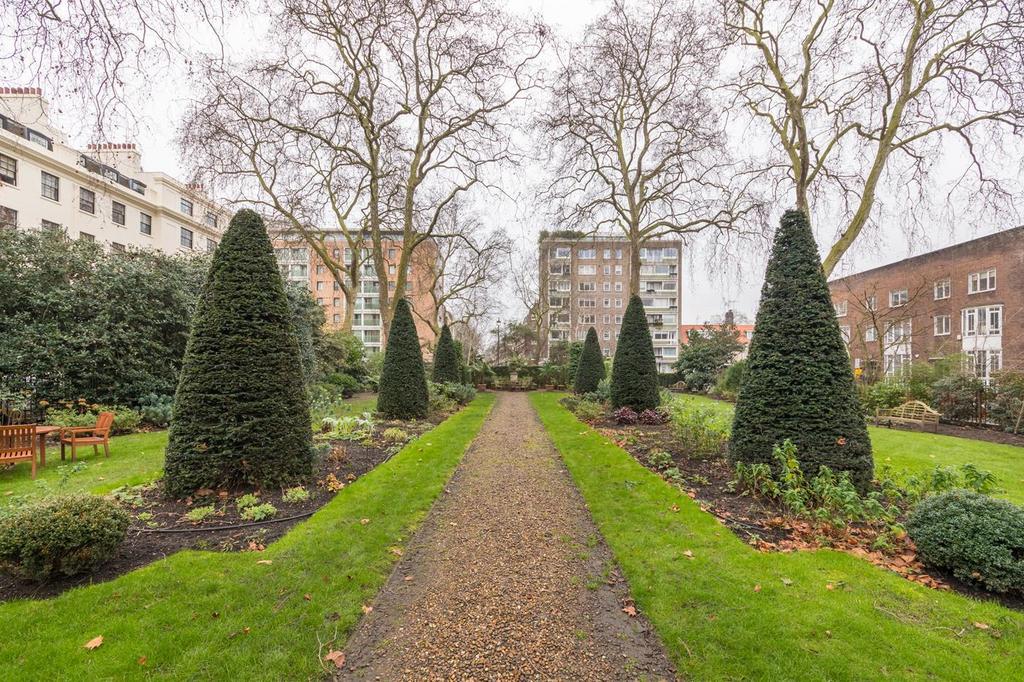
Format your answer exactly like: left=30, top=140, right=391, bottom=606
left=828, top=226, right=1024, bottom=382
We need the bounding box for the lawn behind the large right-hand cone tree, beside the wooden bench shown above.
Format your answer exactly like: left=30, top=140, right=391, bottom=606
left=675, top=394, right=1024, bottom=504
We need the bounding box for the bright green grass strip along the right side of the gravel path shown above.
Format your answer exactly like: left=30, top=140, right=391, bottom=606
left=530, top=393, right=1024, bottom=681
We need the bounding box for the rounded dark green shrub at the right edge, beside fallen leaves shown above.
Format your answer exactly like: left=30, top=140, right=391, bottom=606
left=906, top=491, right=1024, bottom=593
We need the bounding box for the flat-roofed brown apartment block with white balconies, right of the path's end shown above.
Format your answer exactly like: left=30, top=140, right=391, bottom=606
left=539, top=232, right=682, bottom=372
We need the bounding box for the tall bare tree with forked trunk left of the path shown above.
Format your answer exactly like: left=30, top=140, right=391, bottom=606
left=245, top=0, right=545, bottom=334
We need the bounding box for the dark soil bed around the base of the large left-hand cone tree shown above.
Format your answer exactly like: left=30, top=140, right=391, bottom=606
left=0, top=415, right=446, bottom=602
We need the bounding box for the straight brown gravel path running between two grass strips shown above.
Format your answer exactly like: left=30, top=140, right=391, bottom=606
left=339, top=393, right=675, bottom=680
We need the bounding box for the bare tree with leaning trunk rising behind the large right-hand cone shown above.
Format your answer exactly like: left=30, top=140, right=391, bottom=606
left=720, top=0, right=1024, bottom=273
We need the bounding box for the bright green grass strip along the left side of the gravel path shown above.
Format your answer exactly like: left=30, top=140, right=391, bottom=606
left=0, top=394, right=495, bottom=680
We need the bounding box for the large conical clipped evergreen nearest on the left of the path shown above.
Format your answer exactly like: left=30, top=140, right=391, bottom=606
left=164, top=209, right=313, bottom=498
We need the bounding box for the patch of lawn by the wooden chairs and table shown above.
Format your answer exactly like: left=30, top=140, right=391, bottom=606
left=0, top=431, right=167, bottom=505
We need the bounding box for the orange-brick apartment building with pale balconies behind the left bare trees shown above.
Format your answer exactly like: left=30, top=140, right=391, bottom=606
left=273, top=232, right=438, bottom=352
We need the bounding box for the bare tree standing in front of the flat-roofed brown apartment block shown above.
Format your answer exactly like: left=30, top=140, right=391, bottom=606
left=542, top=0, right=757, bottom=293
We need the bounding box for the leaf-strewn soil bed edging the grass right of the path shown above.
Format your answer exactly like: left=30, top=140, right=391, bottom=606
left=594, top=421, right=1024, bottom=610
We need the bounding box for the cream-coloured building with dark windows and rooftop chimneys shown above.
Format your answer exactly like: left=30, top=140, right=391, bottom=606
left=0, top=87, right=230, bottom=253
